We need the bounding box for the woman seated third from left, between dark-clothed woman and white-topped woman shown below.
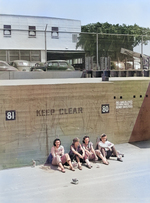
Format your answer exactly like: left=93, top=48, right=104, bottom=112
left=82, top=135, right=107, bottom=168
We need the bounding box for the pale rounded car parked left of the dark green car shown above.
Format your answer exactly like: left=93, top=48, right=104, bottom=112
left=9, top=60, right=31, bottom=72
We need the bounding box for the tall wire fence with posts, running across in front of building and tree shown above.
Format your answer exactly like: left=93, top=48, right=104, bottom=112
left=0, top=29, right=149, bottom=70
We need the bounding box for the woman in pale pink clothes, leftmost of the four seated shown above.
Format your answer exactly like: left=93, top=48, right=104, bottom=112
left=46, top=138, right=75, bottom=173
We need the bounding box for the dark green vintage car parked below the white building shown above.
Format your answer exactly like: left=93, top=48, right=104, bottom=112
left=31, top=60, right=75, bottom=71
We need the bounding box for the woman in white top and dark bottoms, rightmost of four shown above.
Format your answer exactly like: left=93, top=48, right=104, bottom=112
left=97, top=134, right=123, bottom=162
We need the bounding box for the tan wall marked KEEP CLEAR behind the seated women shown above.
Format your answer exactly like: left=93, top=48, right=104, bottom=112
left=0, top=79, right=150, bottom=169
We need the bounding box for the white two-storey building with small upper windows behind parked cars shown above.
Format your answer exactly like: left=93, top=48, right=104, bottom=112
left=0, top=14, right=84, bottom=62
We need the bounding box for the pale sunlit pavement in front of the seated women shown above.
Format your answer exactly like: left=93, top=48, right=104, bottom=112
left=0, top=141, right=150, bottom=203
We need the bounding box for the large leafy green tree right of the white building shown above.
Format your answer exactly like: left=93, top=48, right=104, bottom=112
left=76, top=22, right=150, bottom=60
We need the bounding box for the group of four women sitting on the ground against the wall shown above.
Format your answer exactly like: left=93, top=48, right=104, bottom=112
left=45, top=134, right=122, bottom=173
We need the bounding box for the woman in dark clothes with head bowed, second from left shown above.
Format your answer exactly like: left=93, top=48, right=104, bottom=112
left=69, top=137, right=85, bottom=170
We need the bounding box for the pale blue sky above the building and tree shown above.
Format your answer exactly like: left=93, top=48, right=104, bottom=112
left=0, top=0, right=150, bottom=27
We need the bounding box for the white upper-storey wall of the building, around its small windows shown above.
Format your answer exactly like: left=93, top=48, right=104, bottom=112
left=0, top=14, right=81, bottom=50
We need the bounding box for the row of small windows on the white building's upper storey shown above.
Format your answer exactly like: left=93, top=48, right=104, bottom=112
left=3, top=25, right=77, bottom=42
